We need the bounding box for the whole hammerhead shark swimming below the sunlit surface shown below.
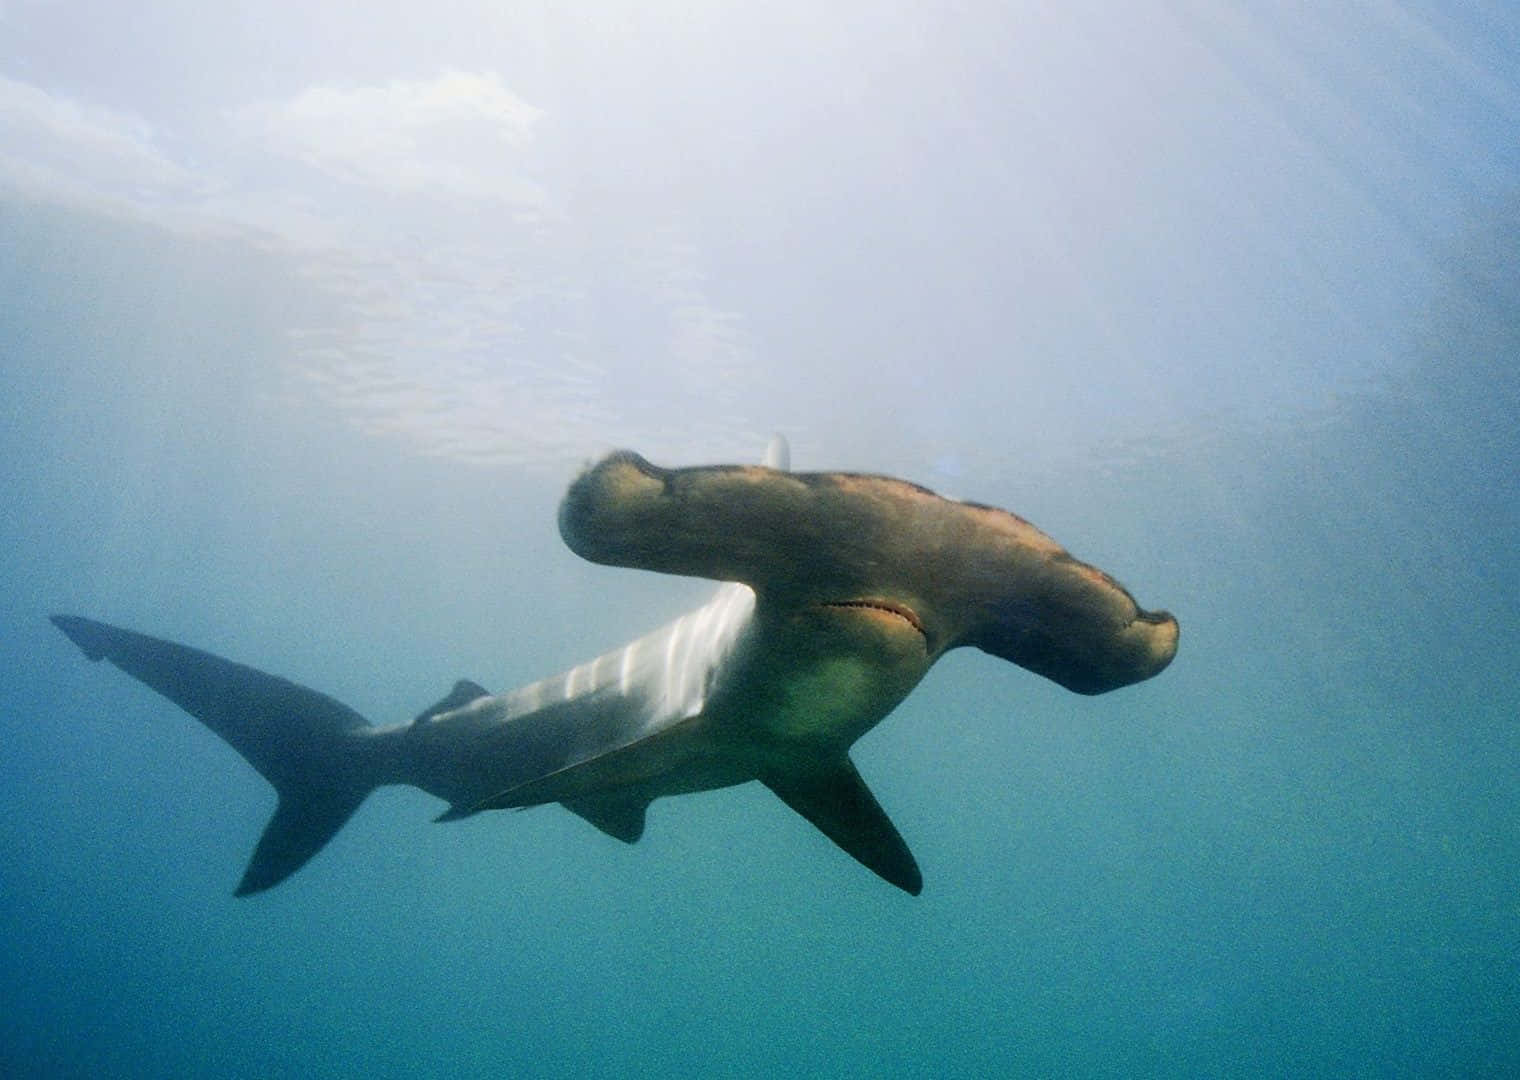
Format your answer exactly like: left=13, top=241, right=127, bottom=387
left=52, top=441, right=1178, bottom=896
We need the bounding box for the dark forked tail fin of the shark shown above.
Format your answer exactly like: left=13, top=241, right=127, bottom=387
left=52, top=615, right=374, bottom=896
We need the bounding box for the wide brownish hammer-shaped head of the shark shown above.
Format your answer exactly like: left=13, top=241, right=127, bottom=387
left=559, top=451, right=1178, bottom=694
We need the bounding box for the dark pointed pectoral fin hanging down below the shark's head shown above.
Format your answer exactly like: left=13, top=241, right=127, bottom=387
left=760, top=758, right=924, bottom=896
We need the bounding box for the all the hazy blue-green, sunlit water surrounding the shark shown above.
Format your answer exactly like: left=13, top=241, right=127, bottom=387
left=0, top=0, right=1520, bottom=1077
